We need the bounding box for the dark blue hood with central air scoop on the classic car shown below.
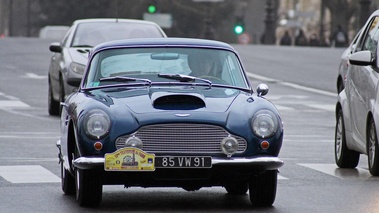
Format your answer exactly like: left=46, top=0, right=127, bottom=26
left=97, top=87, right=241, bottom=114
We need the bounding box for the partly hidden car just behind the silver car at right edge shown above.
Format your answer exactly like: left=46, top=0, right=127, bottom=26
left=337, top=28, right=361, bottom=93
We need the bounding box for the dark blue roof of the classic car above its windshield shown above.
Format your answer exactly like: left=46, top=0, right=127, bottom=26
left=92, top=37, right=236, bottom=53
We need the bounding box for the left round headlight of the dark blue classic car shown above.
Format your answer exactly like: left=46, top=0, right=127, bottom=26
left=84, top=110, right=111, bottom=139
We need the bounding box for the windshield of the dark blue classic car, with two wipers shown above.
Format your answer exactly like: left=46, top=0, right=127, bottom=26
left=85, top=48, right=248, bottom=88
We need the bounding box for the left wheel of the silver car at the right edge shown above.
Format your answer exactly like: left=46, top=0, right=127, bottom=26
left=334, top=110, right=360, bottom=168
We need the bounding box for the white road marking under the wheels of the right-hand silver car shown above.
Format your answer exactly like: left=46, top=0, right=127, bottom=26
left=298, top=164, right=377, bottom=180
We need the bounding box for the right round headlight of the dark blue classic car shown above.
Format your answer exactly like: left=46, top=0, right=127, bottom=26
left=251, top=110, right=278, bottom=138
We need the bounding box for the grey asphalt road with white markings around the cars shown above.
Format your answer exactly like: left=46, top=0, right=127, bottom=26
left=0, top=38, right=379, bottom=213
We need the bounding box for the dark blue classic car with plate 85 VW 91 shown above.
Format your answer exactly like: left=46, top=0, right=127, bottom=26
left=57, top=38, right=283, bottom=206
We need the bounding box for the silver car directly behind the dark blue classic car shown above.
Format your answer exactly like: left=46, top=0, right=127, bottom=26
left=48, top=19, right=166, bottom=115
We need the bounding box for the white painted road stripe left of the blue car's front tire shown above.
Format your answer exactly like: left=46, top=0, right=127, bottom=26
left=0, top=165, right=61, bottom=183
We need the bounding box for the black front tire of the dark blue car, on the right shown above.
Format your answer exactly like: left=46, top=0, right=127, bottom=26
left=249, top=170, right=278, bottom=206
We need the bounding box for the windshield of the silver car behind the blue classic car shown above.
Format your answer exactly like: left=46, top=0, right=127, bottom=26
left=71, top=22, right=163, bottom=47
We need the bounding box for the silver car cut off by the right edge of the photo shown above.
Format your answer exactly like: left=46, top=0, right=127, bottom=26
left=335, top=10, right=379, bottom=176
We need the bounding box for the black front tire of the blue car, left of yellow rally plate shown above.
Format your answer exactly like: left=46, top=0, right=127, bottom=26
left=75, top=169, right=103, bottom=207
